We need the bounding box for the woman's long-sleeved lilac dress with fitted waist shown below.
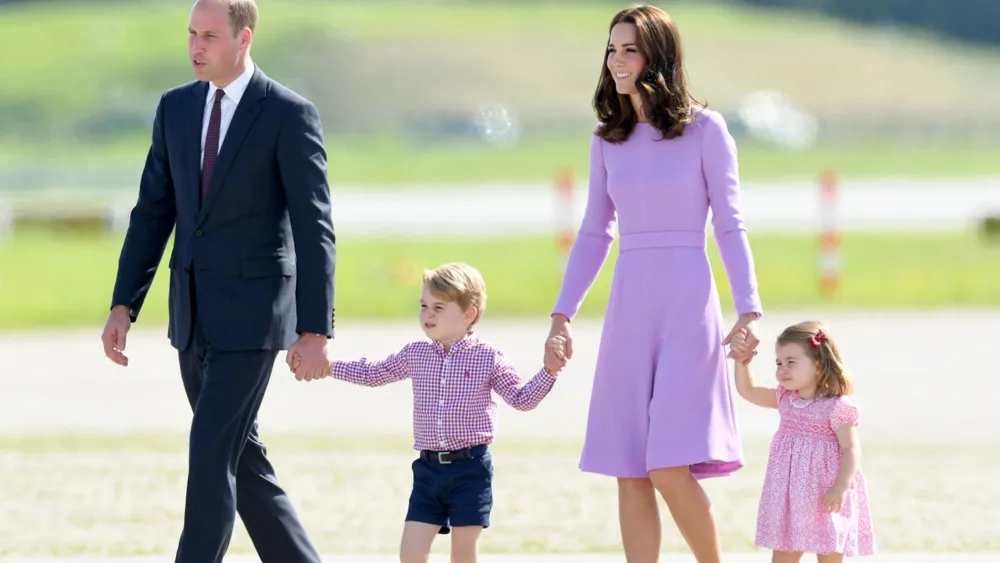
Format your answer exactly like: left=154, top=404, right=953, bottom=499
left=553, top=109, right=762, bottom=478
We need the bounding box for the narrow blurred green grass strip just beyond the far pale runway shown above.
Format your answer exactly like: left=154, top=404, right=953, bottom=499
left=0, top=133, right=1000, bottom=184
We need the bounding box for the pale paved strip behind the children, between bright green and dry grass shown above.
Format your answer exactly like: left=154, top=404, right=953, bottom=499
left=0, top=311, right=1000, bottom=445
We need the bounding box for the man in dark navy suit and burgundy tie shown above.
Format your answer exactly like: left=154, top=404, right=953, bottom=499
left=102, top=0, right=335, bottom=563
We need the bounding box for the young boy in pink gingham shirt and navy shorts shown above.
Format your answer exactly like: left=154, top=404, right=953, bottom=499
left=293, top=263, right=566, bottom=563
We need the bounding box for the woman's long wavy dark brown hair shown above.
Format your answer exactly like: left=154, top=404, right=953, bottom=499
left=593, top=5, right=705, bottom=143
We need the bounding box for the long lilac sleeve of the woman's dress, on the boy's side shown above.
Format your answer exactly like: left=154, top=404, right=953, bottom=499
left=552, top=130, right=615, bottom=319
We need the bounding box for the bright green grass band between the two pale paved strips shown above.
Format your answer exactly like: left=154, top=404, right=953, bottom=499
left=0, top=228, right=1000, bottom=330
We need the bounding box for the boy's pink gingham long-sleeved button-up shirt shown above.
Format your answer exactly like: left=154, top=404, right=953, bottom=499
left=331, top=334, right=556, bottom=451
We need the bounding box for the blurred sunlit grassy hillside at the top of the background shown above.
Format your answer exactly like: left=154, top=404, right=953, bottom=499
left=7, top=0, right=1000, bottom=116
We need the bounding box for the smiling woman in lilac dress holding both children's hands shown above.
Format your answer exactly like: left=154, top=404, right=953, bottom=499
left=551, top=6, right=762, bottom=563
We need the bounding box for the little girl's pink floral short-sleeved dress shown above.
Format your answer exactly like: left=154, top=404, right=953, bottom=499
left=756, top=385, right=875, bottom=557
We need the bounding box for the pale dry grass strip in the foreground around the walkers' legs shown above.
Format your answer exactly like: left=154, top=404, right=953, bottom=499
left=0, top=432, right=1000, bottom=560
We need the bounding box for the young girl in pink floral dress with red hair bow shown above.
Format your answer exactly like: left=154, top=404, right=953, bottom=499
left=732, top=321, right=875, bottom=563
